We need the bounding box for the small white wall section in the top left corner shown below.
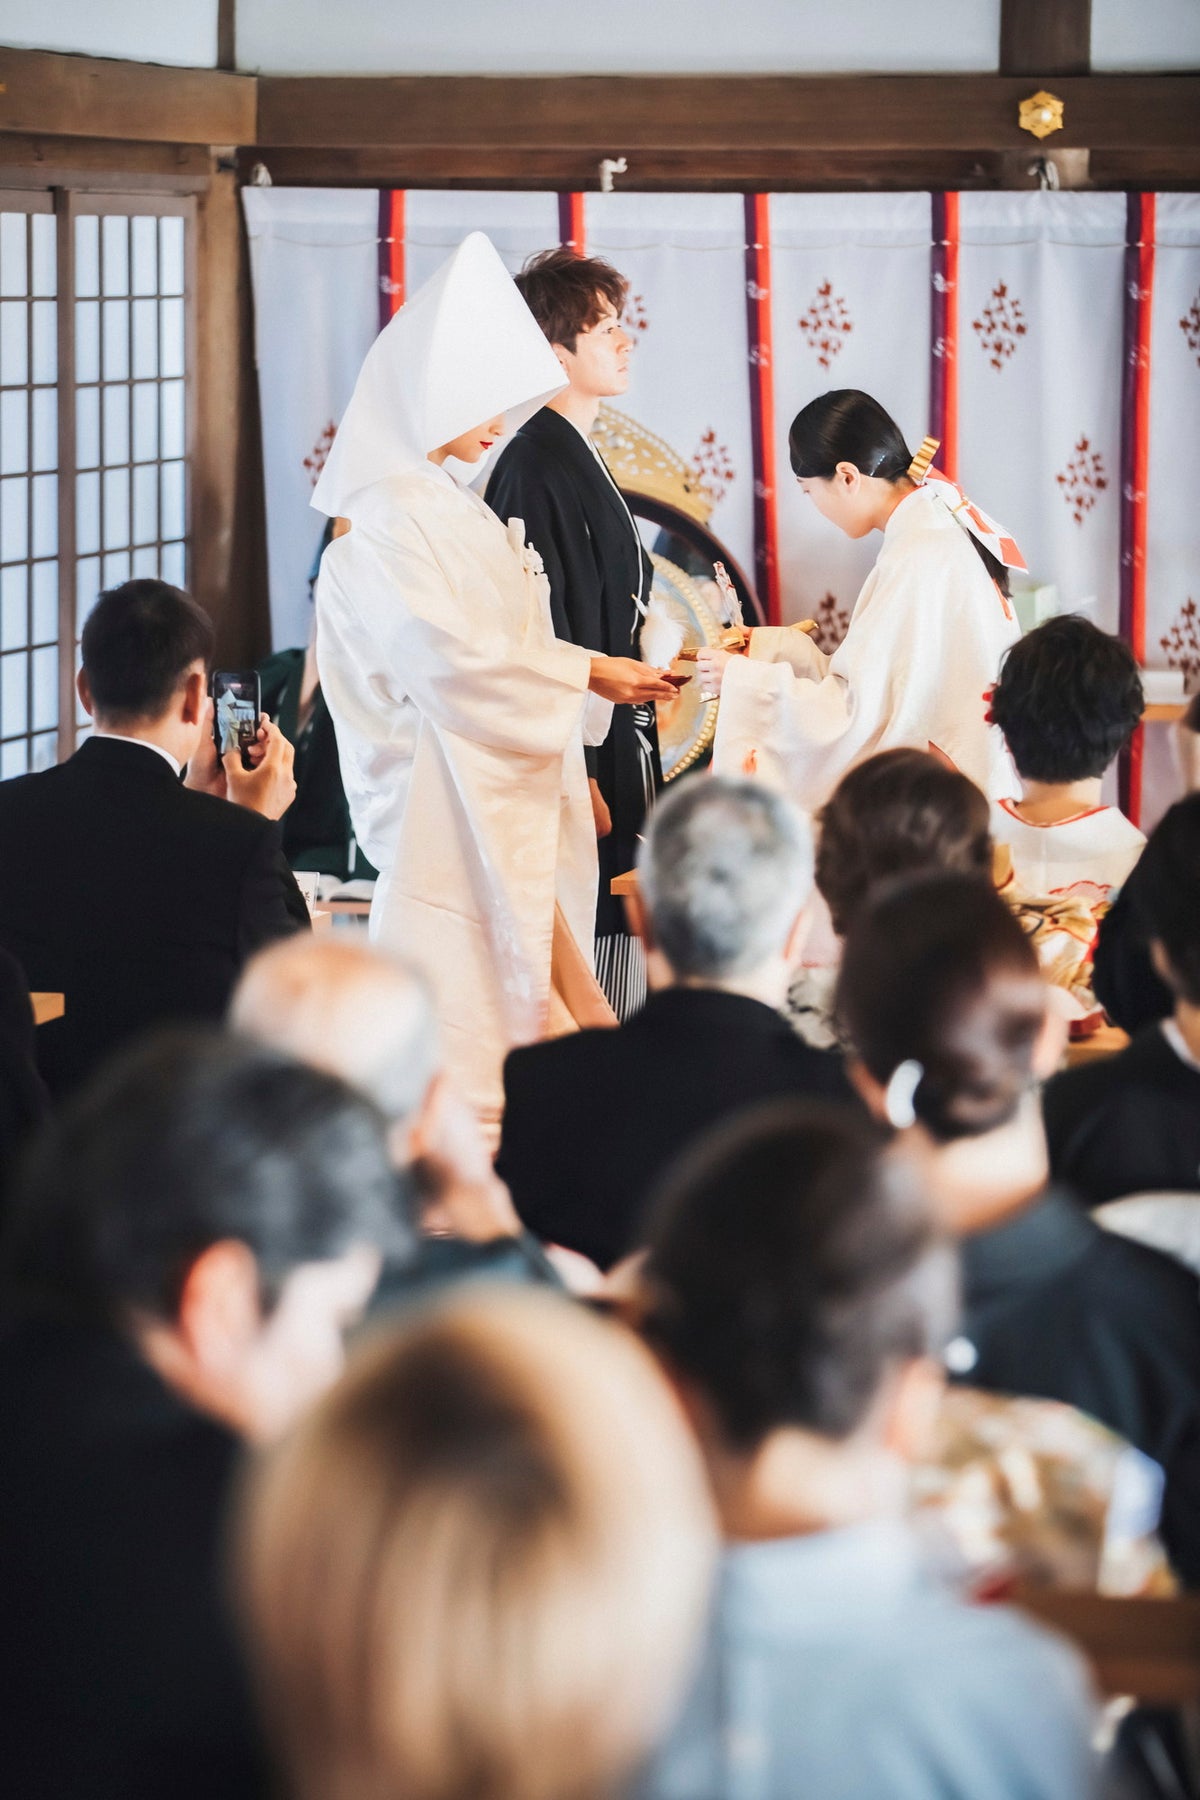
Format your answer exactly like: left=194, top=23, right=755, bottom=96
left=0, top=0, right=218, bottom=68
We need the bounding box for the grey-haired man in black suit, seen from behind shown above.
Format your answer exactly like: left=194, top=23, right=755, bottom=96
left=497, top=778, right=853, bottom=1269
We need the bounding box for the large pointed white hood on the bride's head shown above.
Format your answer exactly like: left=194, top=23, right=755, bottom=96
left=313, top=230, right=567, bottom=518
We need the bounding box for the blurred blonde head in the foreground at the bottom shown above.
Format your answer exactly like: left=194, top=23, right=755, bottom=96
left=241, top=1291, right=712, bottom=1800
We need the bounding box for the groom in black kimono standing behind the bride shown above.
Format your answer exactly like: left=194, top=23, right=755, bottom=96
left=488, top=247, right=662, bottom=1019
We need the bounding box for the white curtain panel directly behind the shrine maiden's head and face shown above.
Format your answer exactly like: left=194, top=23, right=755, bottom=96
left=770, top=194, right=932, bottom=650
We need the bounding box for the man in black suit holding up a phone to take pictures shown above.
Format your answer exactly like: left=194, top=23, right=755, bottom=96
left=0, top=580, right=308, bottom=1096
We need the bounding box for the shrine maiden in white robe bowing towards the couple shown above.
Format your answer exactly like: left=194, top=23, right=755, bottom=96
left=698, top=389, right=1025, bottom=808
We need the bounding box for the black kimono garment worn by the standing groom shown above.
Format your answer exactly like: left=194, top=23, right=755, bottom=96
left=488, top=407, right=662, bottom=936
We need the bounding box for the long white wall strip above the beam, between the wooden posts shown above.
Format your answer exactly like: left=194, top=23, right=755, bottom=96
left=233, top=0, right=1007, bottom=76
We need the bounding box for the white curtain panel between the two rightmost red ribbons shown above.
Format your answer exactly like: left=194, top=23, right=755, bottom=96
left=959, top=193, right=1124, bottom=632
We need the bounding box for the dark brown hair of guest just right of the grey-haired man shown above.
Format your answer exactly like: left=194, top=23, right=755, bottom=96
left=817, top=749, right=991, bottom=936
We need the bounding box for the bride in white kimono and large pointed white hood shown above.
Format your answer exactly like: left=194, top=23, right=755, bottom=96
left=313, top=232, right=675, bottom=1136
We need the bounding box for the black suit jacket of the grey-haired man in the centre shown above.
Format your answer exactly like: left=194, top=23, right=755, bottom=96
left=497, top=988, right=853, bottom=1269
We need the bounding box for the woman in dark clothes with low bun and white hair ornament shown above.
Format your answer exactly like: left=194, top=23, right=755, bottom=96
left=837, top=875, right=1200, bottom=1586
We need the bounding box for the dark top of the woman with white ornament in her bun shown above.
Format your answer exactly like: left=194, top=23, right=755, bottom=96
left=961, top=1192, right=1200, bottom=1588
